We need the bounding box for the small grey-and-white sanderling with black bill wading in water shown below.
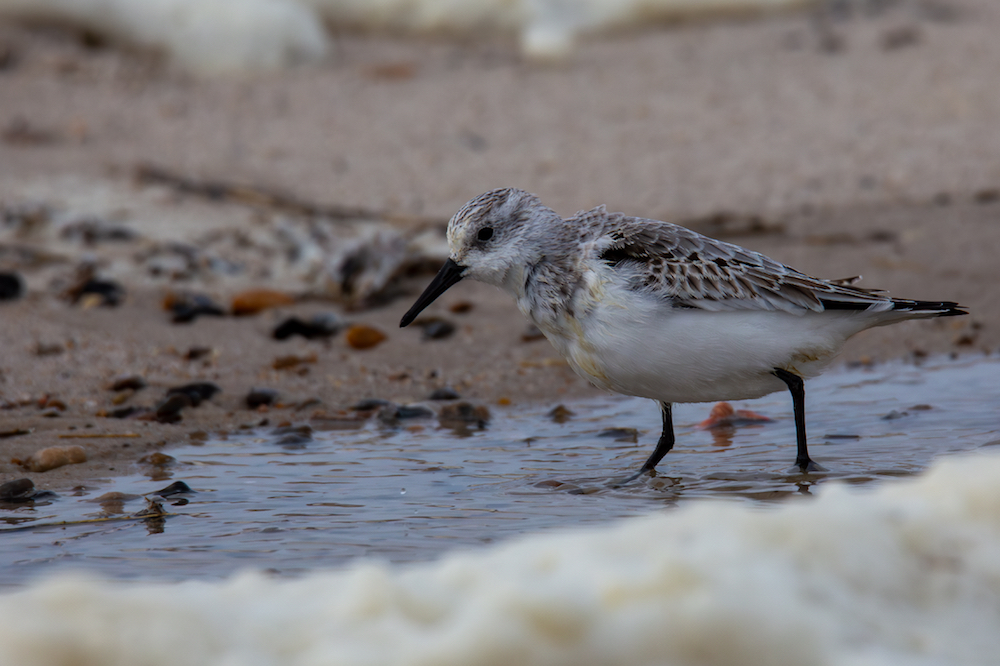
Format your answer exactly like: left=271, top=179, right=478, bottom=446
left=400, top=188, right=968, bottom=483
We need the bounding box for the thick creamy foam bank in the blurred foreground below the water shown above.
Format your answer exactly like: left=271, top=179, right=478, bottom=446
left=0, top=456, right=1000, bottom=666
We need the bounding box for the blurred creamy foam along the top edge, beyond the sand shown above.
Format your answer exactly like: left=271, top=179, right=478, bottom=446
left=0, top=0, right=812, bottom=73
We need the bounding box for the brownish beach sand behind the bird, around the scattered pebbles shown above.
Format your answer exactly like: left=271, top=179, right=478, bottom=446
left=0, top=0, right=1000, bottom=489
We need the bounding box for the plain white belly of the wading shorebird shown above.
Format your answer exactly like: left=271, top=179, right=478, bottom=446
left=540, top=290, right=874, bottom=402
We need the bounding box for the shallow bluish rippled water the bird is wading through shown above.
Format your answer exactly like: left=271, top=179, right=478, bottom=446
left=0, top=357, right=1000, bottom=585
